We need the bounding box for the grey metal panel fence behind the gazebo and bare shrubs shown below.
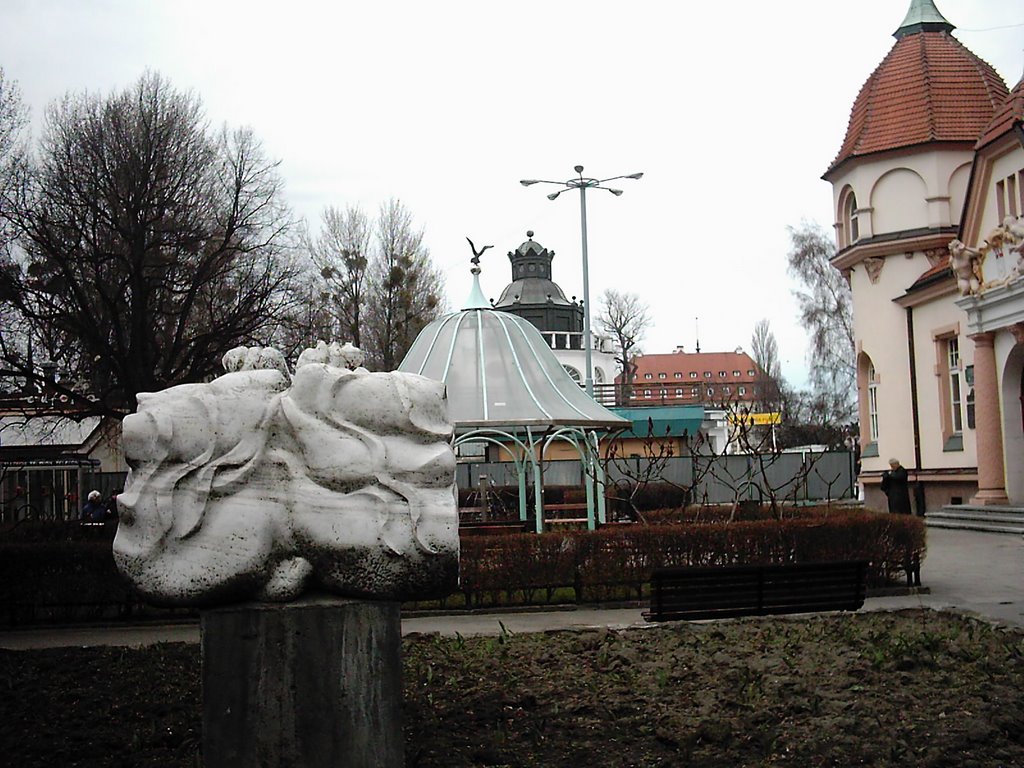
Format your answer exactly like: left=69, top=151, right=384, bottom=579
left=456, top=451, right=856, bottom=504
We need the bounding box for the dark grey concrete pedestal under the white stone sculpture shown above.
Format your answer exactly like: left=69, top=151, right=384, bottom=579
left=202, top=598, right=403, bottom=768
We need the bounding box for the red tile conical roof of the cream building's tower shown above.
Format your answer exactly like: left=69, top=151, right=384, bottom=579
left=825, top=31, right=1008, bottom=176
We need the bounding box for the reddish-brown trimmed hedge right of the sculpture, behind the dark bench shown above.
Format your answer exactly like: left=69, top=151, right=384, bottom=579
left=460, top=510, right=925, bottom=605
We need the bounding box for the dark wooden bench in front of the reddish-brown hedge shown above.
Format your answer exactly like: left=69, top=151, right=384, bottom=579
left=644, top=560, right=867, bottom=622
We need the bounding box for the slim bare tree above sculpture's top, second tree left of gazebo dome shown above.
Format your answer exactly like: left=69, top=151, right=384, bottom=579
left=306, top=206, right=373, bottom=346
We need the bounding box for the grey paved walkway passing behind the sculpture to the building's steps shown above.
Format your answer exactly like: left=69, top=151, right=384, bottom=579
left=0, top=528, right=1024, bottom=650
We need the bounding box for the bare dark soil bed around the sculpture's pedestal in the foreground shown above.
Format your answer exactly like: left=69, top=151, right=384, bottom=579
left=0, top=610, right=1024, bottom=768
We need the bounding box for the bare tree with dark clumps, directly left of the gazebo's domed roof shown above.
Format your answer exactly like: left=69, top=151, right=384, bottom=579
left=364, top=199, right=444, bottom=371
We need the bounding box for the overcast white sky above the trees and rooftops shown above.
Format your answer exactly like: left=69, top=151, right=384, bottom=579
left=0, top=0, right=1024, bottom=384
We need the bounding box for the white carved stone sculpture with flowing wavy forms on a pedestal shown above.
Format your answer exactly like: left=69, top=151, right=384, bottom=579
left=114, top=342, right=459, bottom=605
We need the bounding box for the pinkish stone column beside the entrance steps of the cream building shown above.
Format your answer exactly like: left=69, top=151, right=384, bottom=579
left=971, top=333, right=1010, bottom=505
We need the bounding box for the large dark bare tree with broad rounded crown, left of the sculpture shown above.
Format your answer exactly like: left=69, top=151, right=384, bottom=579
left=3, top=74, right=295, bottom=414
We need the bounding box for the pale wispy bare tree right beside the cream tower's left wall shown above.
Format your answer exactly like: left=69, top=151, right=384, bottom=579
left=788, top=221, right=856, bottom=423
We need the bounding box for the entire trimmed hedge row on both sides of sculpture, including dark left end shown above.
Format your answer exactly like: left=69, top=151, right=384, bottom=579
left=0, top=508, right=925, bottom=626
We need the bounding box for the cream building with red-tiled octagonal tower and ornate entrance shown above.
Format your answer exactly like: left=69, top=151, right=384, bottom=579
left=823, top=0, right=1024, bottom=518
